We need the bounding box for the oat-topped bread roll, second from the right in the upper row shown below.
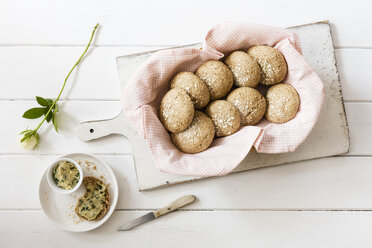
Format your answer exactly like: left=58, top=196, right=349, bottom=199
left=225, top=51, right=261, bottom=87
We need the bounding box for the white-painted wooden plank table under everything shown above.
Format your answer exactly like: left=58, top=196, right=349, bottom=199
left=0, top=0, right=372, bottom=247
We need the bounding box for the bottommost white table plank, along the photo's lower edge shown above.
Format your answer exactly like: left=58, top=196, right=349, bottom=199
left=0, top=211, right=372, bottom=248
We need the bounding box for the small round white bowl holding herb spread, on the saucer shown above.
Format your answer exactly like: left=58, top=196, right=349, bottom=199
left=47, top=158, right=84, bottom=194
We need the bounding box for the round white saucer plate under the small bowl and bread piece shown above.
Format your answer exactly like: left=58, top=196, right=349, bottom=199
left=39, top=153, right=119, bottom=232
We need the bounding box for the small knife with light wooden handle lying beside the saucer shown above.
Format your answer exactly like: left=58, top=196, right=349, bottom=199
left=118, top=195, right=196, bottom=231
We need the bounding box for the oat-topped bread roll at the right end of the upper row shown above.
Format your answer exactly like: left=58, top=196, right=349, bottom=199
left=248, top=46, right=287, bottom=85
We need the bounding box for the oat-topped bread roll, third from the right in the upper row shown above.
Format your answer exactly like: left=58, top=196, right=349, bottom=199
left=196, top=60, right=234, bottom=100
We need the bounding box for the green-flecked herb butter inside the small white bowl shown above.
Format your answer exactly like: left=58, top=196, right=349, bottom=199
left=53, top=161, right=80, bottom=190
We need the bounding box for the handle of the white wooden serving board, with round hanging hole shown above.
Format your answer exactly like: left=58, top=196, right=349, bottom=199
left=76, top=112, right=127, bottom=141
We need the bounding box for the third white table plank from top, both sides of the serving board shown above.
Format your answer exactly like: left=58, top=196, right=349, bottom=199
left=0, top=101, right=366, bottom=155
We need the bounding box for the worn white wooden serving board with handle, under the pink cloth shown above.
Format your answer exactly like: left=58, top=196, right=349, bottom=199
left=77, top=22, right=349, bottom=190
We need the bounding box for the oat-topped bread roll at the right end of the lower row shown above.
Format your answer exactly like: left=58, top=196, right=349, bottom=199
left=266, top=84, right=300, bottom=123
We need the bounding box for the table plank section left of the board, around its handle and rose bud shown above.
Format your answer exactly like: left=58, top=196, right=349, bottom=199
left=0, top=101, right=131, bottom=154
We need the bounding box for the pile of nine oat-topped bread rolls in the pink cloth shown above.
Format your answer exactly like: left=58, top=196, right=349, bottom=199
left=159, top=45, right=300, bottom=153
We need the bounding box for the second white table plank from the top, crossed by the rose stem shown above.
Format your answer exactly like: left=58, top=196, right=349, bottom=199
left=0, top=46, right=372, bottom=101
